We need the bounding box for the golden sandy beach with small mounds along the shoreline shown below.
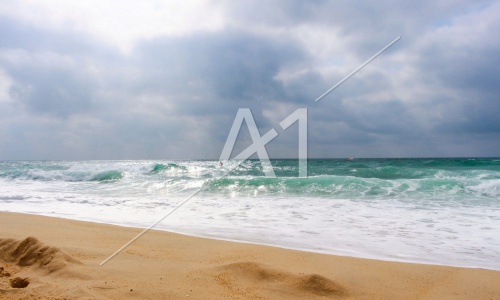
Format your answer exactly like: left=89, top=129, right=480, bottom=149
left=0, top=212, right=500, bottom=299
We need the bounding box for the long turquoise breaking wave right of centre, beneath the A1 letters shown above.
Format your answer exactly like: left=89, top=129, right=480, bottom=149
left=198, top=175, right=492, bottom=201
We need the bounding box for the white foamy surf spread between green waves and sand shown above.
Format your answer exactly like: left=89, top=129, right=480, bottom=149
left=0, top=162, right=500, bottom=270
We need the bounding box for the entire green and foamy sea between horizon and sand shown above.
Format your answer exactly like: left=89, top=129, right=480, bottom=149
left=0, top=158, right=500, bottom=270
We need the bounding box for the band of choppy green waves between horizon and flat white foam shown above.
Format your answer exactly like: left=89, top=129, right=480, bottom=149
left=0, top=159, right=500, bottom=199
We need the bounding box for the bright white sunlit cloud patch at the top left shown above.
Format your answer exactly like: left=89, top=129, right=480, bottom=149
left=0, top=0, right=225, bottom=53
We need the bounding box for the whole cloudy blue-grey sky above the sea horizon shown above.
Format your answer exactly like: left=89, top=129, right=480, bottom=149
left=0, top=0, right=500, bottom=160
